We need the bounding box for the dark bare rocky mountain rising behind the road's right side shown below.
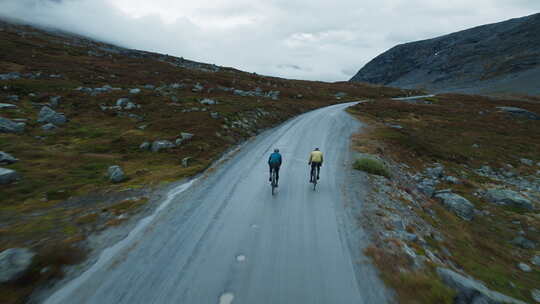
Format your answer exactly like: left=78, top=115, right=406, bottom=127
left=351, top=14, right=540, bottom=95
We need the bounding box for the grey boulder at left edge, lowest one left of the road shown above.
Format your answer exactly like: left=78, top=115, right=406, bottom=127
left=0, top=248, right=35, bottom=283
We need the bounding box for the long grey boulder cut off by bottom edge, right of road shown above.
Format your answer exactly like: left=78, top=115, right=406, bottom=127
left=437, top=267, right=526, bottom=304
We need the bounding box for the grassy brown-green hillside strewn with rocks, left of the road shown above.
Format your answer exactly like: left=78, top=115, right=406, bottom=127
left=0, top=22, right=414, bottom=303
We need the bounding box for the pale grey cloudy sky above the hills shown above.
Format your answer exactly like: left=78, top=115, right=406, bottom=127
left=0, top=0, right=540, bottom=81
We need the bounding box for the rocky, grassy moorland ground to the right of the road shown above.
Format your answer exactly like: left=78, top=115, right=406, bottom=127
left=351, top=95, right=540, bottom=303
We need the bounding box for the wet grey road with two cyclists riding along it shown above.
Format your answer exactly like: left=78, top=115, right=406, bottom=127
left=46, top=104, right=388, bottom=304
